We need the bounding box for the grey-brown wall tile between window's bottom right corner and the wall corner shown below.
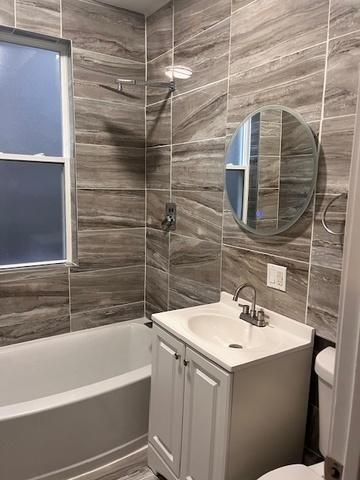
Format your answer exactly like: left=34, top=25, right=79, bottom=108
left=78, top=228, right=145, bottom=270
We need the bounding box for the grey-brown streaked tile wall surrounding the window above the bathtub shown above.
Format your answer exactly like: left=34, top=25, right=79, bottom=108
left=0, top=0, right=145, bottom=346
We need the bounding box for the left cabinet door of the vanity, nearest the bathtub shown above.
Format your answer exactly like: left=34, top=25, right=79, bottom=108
left=149, top=325, right=185, bottom=477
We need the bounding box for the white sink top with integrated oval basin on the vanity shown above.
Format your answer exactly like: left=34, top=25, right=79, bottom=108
left=152, top=292, right=314, bottom=372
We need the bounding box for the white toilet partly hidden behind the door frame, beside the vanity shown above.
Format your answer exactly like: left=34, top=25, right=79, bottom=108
left=258, top=347, right=335, bottom=480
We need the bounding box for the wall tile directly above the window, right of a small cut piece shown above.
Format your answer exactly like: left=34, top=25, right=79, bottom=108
left=15, top=0, right=61, bottom=37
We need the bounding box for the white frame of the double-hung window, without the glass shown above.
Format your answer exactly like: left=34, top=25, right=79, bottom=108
left=0, top=29, right=77, bottom=270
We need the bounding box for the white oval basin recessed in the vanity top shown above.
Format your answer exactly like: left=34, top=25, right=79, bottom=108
left=187, top=313, right=266, bottom=349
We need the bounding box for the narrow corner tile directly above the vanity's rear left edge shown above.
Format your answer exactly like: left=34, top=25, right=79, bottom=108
left=145, top=266, right=169, bottom=313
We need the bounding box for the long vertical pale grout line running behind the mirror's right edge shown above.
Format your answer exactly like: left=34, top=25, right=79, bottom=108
left=305, top=0, right=331, bottom=325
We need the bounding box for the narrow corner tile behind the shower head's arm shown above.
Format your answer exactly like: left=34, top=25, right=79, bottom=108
left=147, top=50, right=173, bottom=105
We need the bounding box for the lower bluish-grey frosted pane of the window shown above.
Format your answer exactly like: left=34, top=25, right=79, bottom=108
left=0, top=160, right=66, bottom=265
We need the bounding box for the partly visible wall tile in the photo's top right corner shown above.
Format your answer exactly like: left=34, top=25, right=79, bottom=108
left=330, top=0, right=360, bottom=38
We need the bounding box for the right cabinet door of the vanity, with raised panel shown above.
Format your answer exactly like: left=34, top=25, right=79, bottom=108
left=180, top=348, right=232, bottom=480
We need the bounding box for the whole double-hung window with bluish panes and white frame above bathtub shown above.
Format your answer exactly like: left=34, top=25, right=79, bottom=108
left=0, top=33, right=73, bottom=268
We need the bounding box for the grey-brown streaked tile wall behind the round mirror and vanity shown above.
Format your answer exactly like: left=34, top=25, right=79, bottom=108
left=146, top=0, right=360, bottom=340
